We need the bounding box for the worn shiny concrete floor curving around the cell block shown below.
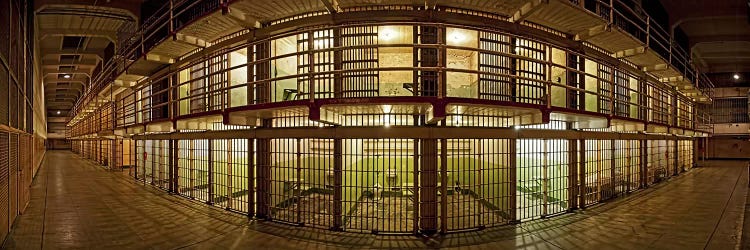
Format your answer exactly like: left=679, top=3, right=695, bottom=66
left=3, top=151, right=750, bottom=249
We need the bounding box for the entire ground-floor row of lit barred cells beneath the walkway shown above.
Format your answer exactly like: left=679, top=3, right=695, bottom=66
left=122, top=138, right=694, bottom=233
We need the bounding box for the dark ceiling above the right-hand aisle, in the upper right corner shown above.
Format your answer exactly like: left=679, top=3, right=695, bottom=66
left=661, top=0, right=750, bottom=87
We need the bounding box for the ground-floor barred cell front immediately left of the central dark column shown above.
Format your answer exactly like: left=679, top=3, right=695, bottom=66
left=341, top=139, right=420, bottom=233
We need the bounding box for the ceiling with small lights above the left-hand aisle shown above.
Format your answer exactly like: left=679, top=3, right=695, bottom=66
left=36, top=1, right=139, bottom=121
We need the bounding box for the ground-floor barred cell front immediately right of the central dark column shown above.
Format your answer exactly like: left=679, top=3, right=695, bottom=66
left=437, top=139, right=520, bottom=231
